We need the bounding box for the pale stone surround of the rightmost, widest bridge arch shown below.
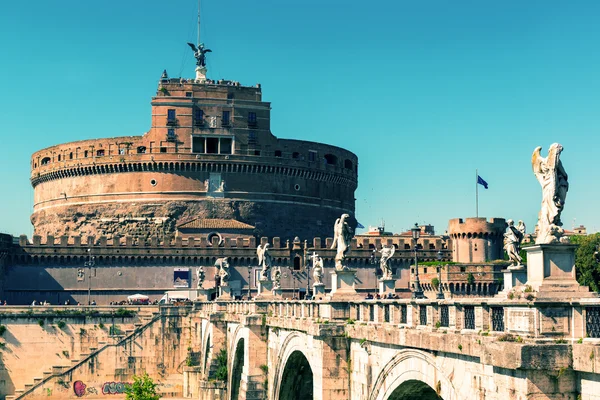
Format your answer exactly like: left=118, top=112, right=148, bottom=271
left=369, top=349, right=458, bottom=400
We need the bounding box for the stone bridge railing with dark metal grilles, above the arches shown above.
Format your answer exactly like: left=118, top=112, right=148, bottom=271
left=210, top=298, right=600, bottom=341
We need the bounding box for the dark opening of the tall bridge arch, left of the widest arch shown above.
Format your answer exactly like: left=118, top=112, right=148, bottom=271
left=279, top=350, right=313, bottom=400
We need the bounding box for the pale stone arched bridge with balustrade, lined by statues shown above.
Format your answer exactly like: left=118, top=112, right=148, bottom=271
left=184, top=299, right=600, bottom=400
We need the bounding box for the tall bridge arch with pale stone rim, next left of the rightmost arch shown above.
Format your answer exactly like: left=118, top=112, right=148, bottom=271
left=272, top=332, right=321, bottom=400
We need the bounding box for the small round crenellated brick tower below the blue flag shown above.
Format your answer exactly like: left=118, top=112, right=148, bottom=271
left=448, top=218, right=507, bottom=263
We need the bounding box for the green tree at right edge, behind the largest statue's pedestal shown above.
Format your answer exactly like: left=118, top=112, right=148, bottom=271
left=571, top=233, right=600, bottom=292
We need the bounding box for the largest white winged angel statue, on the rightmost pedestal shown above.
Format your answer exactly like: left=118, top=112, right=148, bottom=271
left=531, top=143, right=569, bottom=244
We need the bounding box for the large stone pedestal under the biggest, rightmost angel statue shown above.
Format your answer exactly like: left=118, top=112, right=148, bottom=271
left=524, top=243, right=594, bottom=299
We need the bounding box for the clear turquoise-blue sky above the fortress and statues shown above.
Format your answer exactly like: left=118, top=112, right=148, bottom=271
left=0, top=0, right=600, bottom=234
